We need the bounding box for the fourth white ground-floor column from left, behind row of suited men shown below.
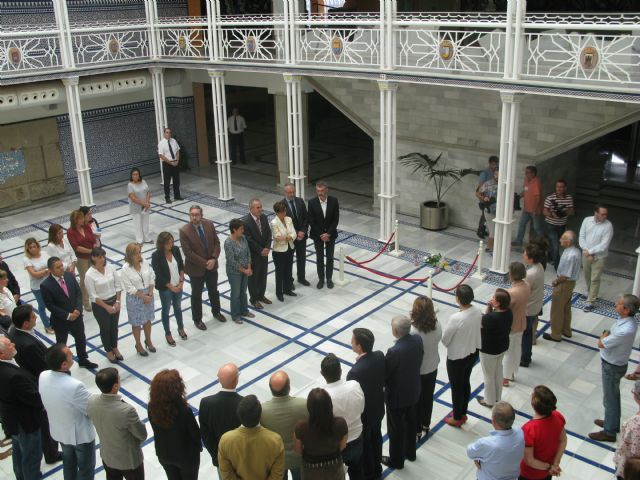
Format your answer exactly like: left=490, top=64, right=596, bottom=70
left=284, top=73, right=305, bottom=198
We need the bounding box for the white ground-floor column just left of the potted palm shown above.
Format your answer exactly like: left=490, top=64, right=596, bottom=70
left=378, top=81, right=398, bottom=242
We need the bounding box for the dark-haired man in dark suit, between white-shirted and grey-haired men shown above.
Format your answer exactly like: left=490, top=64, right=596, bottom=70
left=347, top=328, right=385, bottom=480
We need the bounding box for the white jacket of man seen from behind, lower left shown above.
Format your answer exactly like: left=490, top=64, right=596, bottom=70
left=38, top=370, right=96, bottom=445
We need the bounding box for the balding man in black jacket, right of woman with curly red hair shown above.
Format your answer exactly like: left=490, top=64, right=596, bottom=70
left=200, top=363, right=243, bottom=467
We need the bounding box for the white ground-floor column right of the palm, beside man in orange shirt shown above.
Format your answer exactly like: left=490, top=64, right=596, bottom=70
left=491, top=91, right=522, bottom=273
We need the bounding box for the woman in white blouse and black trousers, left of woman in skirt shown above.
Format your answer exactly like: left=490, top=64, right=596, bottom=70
left=84, top=247, right=124, bottom=363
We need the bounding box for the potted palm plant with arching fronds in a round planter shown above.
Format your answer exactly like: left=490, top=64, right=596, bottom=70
left=399, top=152, right=480, bottom=230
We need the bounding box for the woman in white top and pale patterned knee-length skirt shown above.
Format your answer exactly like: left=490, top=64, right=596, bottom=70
left=120, top=243, right=156, bottom=357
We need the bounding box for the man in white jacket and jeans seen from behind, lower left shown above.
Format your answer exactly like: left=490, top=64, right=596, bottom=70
left=39, top=343, right=96, bottom=480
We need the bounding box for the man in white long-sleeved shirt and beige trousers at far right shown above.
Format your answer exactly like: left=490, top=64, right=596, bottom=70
left=579, top=205, right=613, bottom=312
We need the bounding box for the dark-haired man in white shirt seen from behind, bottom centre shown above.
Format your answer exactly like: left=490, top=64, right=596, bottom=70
left=320, top=353, right=364, bottom=480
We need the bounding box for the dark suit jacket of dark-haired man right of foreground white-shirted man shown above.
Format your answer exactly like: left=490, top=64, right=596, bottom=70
left=347, top=350, right=385, bottom=425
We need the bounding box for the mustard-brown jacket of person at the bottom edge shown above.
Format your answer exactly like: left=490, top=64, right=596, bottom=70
left=218, top=425, right=285, bottom=480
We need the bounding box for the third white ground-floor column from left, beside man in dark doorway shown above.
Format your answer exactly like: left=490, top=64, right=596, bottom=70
left=208, top=70, right=233, bottom=201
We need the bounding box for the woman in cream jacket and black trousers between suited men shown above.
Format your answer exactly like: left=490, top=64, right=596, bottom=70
left=271, top=201, right=297, bottom=302
